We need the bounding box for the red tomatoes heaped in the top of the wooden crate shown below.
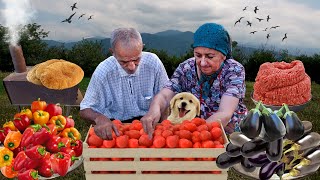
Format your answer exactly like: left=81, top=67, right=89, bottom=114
left=87, top=118, right=225, bottom=148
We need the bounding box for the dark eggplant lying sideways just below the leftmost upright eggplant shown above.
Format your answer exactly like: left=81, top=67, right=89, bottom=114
left=240, top=138, right=268, bottom=157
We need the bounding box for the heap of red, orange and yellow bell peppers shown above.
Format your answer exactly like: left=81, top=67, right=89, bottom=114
left=0, top=99, right=83, bottom=179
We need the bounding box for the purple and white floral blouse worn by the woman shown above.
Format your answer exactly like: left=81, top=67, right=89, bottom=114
left=164, top=57, right=247, bottom=134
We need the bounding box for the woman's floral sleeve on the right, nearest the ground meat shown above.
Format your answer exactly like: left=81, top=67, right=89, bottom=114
left=224, top=64, right=246, bottom=99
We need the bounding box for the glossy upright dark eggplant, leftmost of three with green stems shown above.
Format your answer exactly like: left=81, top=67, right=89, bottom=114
left=240, top=102, right=262, bottom=138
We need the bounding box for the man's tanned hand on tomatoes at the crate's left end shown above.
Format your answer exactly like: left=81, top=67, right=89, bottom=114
left=94, top=115, right=120, bottom=140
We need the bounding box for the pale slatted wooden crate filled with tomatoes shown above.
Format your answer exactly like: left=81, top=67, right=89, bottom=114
left=83, top=123, right=229, bottom=180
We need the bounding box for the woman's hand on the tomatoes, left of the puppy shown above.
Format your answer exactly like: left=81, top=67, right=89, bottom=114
left=140, top=111, right=161, bottom=139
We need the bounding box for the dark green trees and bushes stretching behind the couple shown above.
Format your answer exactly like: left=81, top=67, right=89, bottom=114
left=0, top=23, right=320, bottom=84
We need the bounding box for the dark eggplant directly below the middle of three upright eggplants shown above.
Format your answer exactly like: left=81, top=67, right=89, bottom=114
left=266, top=138, right=283, bottom=161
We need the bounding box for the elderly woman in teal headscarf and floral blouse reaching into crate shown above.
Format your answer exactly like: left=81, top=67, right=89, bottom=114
left=141, top=23, right=247, bottom=137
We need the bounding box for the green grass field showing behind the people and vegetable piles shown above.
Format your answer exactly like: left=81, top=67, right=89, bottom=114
left=0, top=72, right=320, bottom=180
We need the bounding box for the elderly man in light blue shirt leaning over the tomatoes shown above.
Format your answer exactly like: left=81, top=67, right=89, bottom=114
left=80, top=28, right=168, bottom=139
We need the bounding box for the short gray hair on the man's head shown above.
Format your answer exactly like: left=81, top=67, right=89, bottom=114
left=110, top=28, right=142, bottom=50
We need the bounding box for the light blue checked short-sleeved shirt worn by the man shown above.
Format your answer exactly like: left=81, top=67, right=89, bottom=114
left=80, top=52, right=168, bottom=120
